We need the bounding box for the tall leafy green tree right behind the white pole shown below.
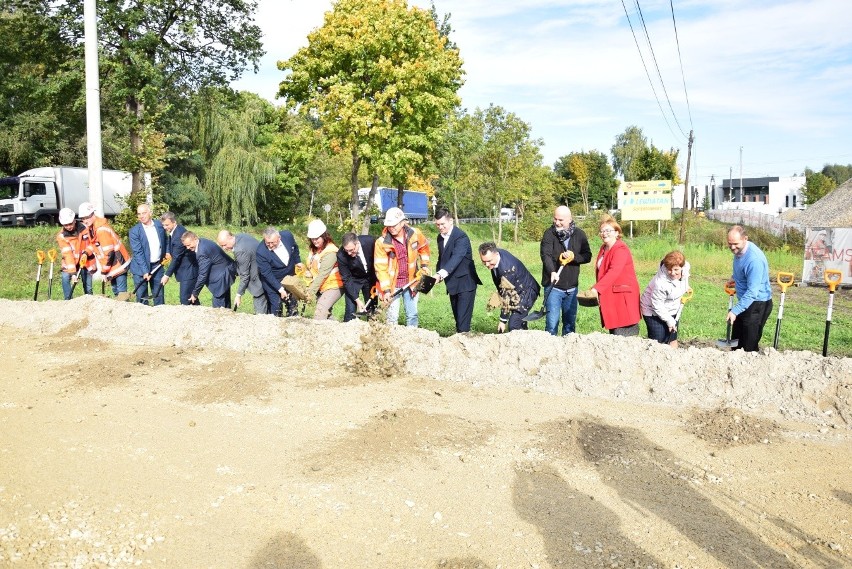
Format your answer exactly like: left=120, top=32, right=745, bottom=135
left=51, top=0, right=263, bottom=193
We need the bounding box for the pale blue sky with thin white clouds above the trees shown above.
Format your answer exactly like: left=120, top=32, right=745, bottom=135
left=228, top=0, right=852, bottom=191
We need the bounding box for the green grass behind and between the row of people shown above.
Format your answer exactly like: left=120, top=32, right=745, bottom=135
left=0, top=219, right=852, bottom=357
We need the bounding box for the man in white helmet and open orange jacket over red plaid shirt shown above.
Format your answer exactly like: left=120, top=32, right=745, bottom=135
left=373, top=207, right=429, bottom=328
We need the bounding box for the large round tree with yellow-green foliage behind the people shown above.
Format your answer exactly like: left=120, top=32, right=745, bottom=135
left=278, top=0, right=462, bottom=230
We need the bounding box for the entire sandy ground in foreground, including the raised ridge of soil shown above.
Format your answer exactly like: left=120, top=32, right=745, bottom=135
left=0, top=297, right=852, bottom=569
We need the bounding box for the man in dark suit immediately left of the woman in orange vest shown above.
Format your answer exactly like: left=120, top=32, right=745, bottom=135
left=255, top=227, right=302, bottom=316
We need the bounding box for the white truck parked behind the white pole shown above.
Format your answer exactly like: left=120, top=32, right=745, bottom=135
left=0, top=166, right=132, bottom=227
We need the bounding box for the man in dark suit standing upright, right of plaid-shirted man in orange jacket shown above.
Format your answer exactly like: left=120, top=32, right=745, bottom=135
left=435, top=207, right=482, bottom=332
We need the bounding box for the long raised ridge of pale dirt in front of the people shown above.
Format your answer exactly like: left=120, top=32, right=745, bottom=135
left=5, top=296, right=852, bottom=425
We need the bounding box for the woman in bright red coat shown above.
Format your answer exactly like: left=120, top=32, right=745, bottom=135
left=591, top=215, right=642, bottom=336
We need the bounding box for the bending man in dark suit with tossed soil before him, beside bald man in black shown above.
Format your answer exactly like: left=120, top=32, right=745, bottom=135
left=479, top=241, right=541, bottom=333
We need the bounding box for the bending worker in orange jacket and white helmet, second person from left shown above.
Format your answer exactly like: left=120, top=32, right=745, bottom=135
left=79, top=202, right=130, bottom=300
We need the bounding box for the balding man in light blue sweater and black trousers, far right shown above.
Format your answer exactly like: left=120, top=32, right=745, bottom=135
left=728, top=225, right=772, bottom=352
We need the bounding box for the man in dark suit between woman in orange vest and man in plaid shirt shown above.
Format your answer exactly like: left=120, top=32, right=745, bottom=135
left=337, top=233, right=376, bottom=322
